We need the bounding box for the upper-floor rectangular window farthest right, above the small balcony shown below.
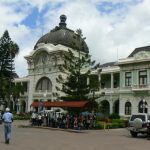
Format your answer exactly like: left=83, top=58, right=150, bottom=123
left=139, top=70, right=147, bottom=85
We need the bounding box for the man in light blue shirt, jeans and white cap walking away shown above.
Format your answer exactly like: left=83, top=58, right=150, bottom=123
left=2, top=108, right=13, bottom=144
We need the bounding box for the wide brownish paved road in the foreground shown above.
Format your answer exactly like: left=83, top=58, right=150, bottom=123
left=0, top=121, right=150, bottom=150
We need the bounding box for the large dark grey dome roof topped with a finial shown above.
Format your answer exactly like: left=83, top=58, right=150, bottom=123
left=34, top=15, right=89, bottom=53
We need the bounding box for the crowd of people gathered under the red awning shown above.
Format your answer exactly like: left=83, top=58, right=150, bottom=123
left=31, top=112, right=96, bottom=130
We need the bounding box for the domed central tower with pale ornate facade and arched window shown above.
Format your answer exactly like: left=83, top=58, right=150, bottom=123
left=25, top=15, right=89, bottom=109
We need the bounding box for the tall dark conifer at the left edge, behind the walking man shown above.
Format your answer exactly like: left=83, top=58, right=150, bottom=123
left=0, top=30, right=19, bottom=106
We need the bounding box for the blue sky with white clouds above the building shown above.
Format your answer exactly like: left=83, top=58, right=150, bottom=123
left=0, top=0, right=150, bottom=77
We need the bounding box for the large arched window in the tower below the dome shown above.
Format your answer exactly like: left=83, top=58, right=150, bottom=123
left=36, top=77, right=52, bottom=92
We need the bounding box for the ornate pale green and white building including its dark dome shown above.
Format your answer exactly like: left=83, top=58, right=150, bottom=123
left=14, top=15, right=150, bottom=117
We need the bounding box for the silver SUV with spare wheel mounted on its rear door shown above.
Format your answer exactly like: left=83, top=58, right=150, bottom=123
left=128, top=113, right=150, bottom=137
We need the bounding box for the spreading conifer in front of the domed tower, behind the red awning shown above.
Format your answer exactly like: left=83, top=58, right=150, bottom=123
left=56, top=29, right=99, bottom=100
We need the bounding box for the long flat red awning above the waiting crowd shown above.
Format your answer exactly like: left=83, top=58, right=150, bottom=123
left=31, top=101, right=89, bottom=108
